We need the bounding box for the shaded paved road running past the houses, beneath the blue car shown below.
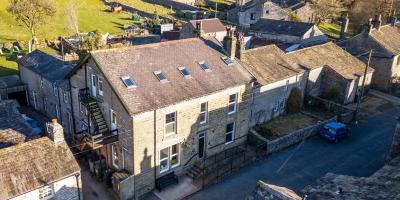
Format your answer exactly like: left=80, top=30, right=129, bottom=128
left=189, top=109, right=398, bottom=200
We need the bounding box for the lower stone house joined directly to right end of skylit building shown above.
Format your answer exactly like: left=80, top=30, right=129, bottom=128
left=240, top=45, right=307, bottom=126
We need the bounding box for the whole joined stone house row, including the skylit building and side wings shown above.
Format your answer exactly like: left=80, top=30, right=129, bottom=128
left=19, top=31, right=373, bottom=199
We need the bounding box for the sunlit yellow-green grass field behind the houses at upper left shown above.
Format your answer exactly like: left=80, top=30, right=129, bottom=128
left=0, top=0, right=170, bottom=76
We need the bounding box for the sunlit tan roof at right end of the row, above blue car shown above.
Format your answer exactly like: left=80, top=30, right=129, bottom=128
left=286, top=42, right=374, bottom=79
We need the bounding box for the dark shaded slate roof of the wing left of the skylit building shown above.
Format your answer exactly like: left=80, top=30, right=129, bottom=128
left=17, top=50, right=73, bottom=83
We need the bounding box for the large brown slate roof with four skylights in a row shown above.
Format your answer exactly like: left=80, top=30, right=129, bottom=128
left=77, top=38, right=251, bottom=114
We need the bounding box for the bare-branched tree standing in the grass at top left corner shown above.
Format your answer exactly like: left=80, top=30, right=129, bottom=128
left=7, top=0, right=56, bottom=38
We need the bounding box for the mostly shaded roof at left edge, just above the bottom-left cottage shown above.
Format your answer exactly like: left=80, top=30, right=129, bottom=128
left=0, top=100, right=38, bottom=148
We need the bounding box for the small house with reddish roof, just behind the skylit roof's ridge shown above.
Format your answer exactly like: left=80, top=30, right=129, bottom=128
left=180, top=18, right=227, bottom=42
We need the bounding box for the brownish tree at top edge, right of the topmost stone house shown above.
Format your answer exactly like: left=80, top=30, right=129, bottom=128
left=312, top=0, right=346, bottom=24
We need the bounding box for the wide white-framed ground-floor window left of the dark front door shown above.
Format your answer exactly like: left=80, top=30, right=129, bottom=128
left=159, top=143, right=181, bottom=173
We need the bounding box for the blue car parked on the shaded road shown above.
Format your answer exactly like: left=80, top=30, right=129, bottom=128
left=319, top=122, right=350, bottom=143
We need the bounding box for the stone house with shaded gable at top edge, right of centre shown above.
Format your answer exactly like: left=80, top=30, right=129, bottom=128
left=228, top=0, right=315, bottom=25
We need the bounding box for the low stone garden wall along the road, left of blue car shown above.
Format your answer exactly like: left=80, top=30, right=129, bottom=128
left=249, top=117, right=337, bottom=155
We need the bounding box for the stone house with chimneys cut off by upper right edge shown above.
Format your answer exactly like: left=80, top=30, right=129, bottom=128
left=338, top=19, right=400, bottom=91
